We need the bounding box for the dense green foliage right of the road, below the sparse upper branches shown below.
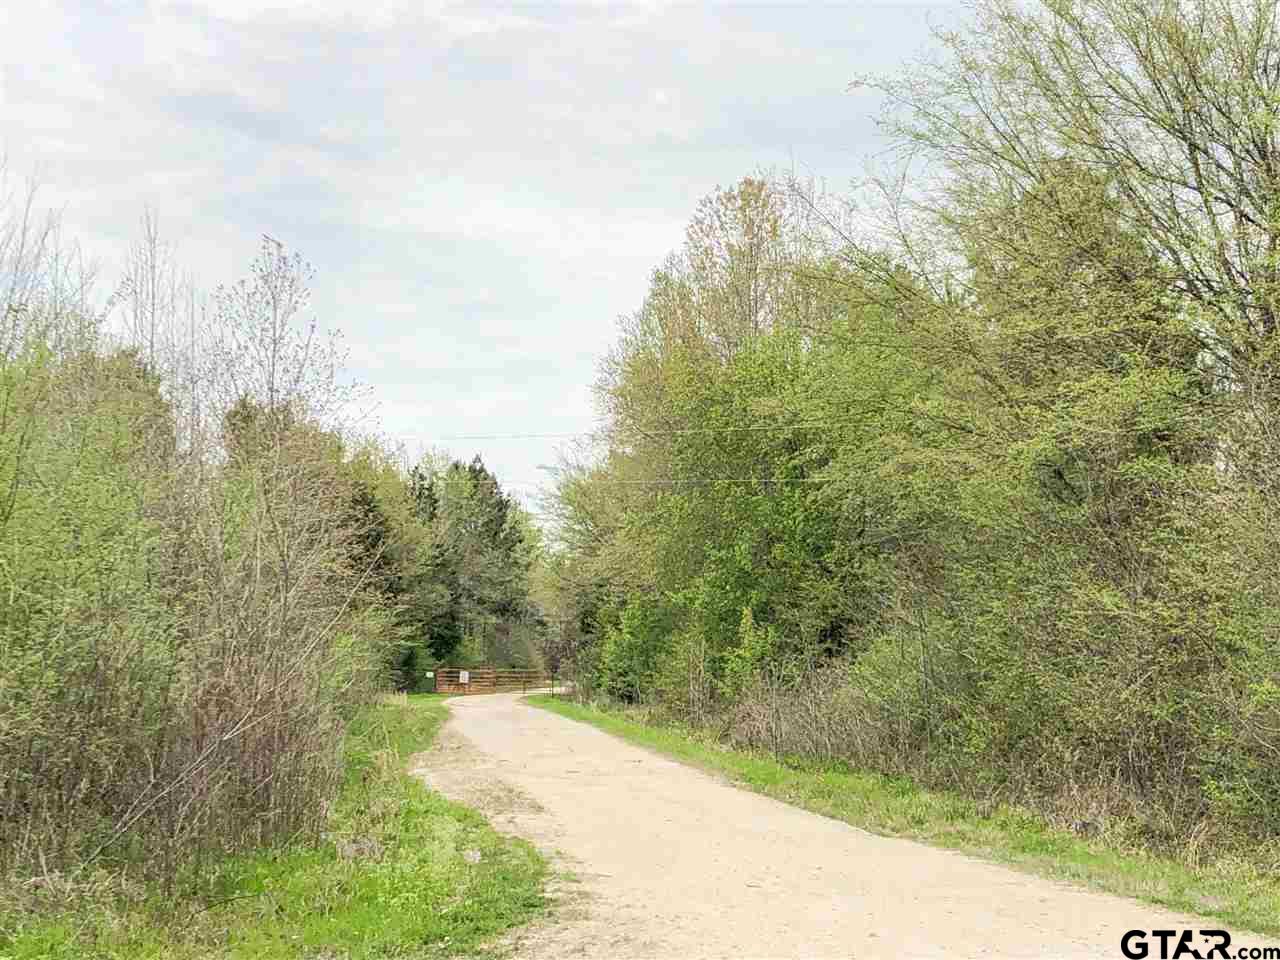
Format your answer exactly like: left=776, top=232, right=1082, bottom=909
left=548, top=154, right=1280, bottom=858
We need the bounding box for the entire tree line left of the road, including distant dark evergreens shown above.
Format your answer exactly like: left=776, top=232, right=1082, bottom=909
left=0, top=197, right=541, bottom=888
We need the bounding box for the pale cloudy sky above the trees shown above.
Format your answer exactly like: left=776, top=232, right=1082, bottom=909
left=0, top=0, right=956, bottom=506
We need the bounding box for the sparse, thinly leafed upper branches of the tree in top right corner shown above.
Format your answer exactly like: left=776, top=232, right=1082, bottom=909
left=863, top=0, right=1280, bottom=376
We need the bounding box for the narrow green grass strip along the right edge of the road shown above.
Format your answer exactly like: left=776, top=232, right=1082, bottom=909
left=527, top=695, right=1280, bottom=936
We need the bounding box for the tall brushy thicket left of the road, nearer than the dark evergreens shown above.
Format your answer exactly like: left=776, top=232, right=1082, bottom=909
left=0, top=231, right=394, bottom=879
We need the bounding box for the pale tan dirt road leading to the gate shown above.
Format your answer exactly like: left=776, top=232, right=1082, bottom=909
left=417, top=695, right=1260, bottom=960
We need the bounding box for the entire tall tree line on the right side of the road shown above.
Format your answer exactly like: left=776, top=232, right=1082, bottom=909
left=545, top=0, right=1280, bottom=859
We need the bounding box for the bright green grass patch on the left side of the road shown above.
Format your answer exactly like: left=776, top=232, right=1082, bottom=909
left=0, top=695, right=547, bottom=960
